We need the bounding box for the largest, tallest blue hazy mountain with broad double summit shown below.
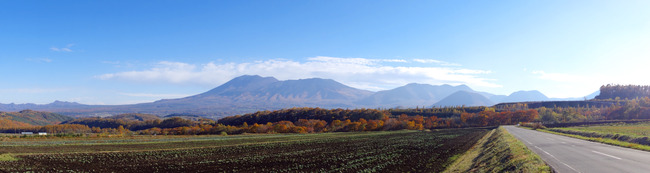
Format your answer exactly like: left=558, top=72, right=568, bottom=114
left=43, top=75, right=372, bottom=118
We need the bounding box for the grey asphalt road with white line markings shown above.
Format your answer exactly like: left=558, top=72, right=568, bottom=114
left=505, top=126, right=650, bottom=173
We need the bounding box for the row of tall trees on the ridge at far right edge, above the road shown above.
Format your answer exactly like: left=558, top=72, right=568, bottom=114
left=596, top=84, right=650, bottom=100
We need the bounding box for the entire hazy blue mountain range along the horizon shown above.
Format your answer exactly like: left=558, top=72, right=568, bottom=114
left=0, top=75, right=597, bottom=118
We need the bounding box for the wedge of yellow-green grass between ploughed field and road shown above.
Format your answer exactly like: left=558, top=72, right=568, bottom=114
left=445, top=127, right=551, bottom=172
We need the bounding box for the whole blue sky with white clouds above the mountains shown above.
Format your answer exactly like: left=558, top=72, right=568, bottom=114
left=0, top=0, right=650, bottom=104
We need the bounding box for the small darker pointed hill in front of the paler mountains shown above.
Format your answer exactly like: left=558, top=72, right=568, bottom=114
left=433, top=91, right=495, bottom=106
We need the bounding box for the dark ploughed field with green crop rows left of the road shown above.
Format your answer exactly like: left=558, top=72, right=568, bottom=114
left=0, top=128, right=490, bottom=172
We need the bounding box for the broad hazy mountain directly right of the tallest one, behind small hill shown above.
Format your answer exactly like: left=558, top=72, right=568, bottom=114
left=357, top=83, right=473, bottom=107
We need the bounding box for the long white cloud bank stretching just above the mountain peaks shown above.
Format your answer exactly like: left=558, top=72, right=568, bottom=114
left=97, top=56, right=501, bottom=90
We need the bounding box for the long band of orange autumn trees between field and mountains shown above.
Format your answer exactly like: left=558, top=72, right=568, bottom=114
left=0, top=108, right=538, bottom=135
